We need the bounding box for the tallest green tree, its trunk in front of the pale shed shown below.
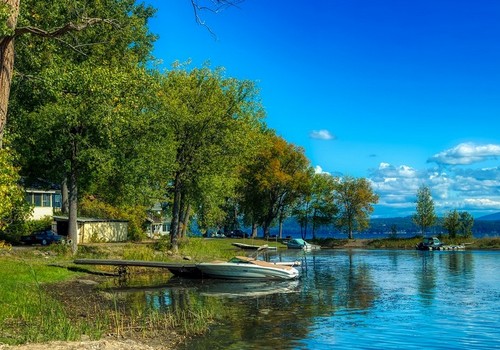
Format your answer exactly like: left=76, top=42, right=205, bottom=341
left=7, top=0, right=154, bottom=249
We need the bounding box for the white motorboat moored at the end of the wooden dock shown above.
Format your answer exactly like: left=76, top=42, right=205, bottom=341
left=196, top=256, right=299, bottom=280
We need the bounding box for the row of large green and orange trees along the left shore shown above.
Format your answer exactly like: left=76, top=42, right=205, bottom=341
left=0, top=0, right=378, bottom=251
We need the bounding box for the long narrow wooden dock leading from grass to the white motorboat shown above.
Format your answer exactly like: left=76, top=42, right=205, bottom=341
left=74, top=259, right=201, bottom=277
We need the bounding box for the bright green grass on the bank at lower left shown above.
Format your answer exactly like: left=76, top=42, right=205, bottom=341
left=0, top=254, right=102, bottom=344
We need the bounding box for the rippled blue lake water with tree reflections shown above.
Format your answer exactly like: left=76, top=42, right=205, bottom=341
left=114, top=250, right=500, bottom=349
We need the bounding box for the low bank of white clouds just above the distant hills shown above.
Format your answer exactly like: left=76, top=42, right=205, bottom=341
left=368, top=163, right=500, bottom=216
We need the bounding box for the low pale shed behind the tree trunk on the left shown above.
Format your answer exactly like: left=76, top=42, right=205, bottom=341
left=54, top=216, right=128, bottom=244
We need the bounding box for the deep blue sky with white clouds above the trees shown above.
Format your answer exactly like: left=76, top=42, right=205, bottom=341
left=147, top=0, right=500, bottom=217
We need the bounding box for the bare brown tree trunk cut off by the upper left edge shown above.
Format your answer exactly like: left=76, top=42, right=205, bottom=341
left=0, top=0, right=20, bottom=148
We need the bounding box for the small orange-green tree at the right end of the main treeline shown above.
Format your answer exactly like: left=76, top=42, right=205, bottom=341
left=334, top=176, right=378, bottom=239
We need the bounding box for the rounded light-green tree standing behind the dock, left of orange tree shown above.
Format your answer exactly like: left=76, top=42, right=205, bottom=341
left=158, top=67, right=263, bottom=251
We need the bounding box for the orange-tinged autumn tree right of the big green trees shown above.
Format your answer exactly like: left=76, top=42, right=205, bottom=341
left=242, top=133, right=311, bottom=237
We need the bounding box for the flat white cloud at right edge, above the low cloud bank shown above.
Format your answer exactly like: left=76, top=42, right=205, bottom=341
left=428, top=142, right=500, bottom=165
